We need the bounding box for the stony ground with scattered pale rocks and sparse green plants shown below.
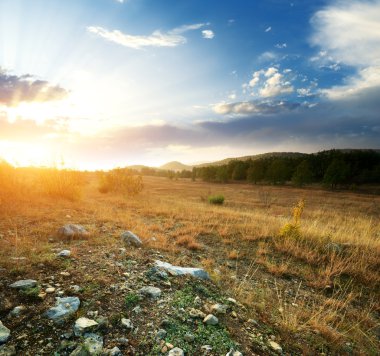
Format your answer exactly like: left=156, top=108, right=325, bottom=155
left=0, top=225, right=282, bottom=355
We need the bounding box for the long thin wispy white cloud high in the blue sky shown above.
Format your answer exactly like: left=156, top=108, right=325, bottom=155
left=87, top=23, right=207, bottom=49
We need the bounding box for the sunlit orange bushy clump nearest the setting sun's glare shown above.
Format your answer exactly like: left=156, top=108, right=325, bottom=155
left=36, top=168, right=85, bottom=201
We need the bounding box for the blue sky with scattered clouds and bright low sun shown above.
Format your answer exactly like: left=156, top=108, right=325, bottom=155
left=0, top=0, right=380, bottom=169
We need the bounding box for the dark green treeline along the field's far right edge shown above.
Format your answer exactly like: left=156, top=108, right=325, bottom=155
left=191, top=150, right=380, bottom=188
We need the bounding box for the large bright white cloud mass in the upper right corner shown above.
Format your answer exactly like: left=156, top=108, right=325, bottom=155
left=311, top=0, right=380, bottom=99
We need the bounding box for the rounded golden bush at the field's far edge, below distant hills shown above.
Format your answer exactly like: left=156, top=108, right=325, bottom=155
left=98, top=168, right=144, bottom=196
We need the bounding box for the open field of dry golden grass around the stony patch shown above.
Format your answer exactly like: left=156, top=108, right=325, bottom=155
left=0, top=173, right=380, bottom=355
